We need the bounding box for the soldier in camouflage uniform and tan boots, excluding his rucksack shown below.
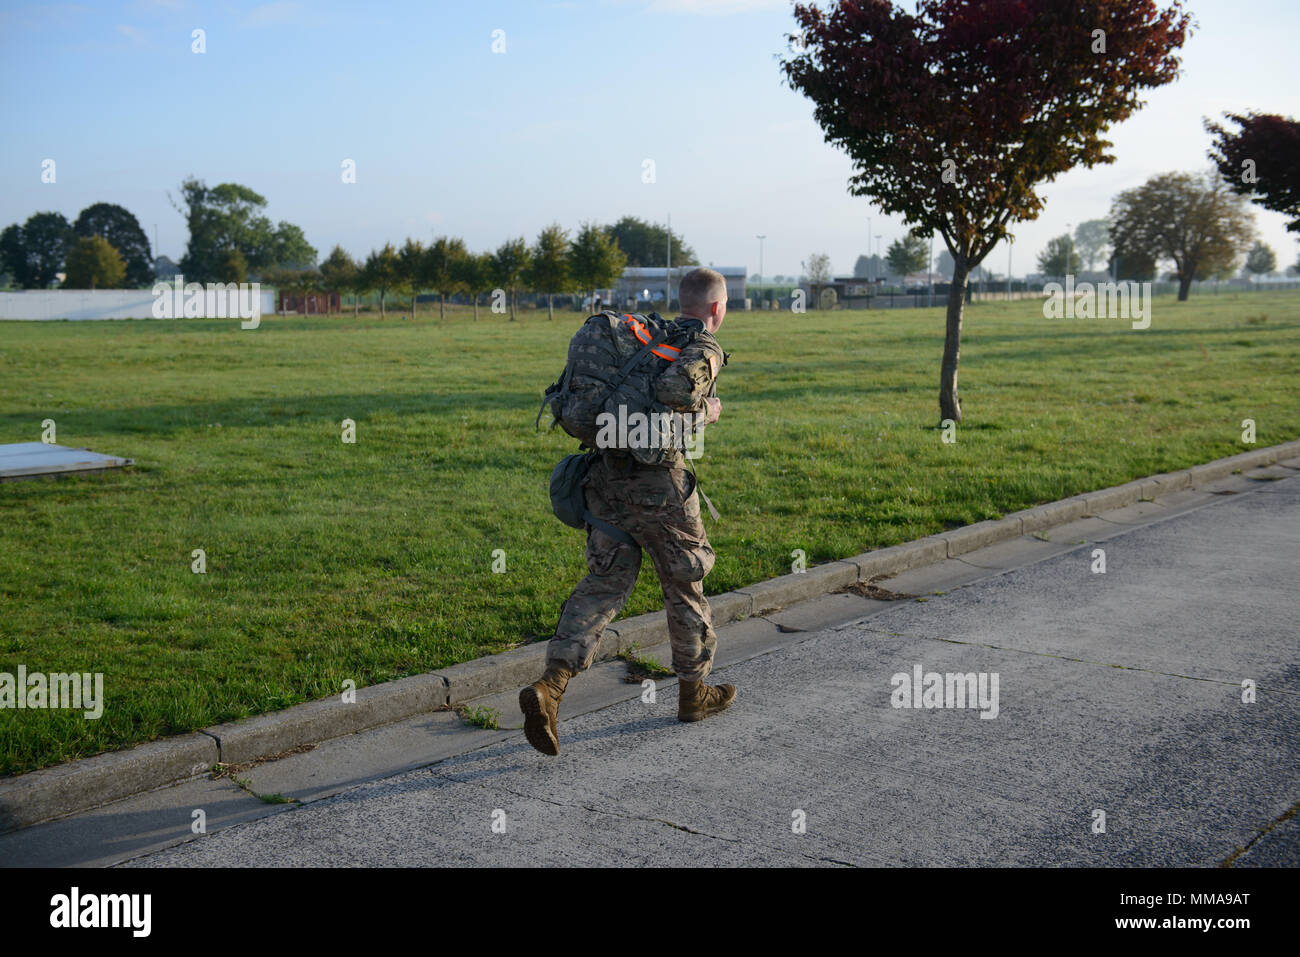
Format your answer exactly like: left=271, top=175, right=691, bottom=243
left=519, top=269, right=736, bottom=754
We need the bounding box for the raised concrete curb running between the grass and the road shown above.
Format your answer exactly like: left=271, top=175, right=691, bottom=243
left=0, top=439, right=1300, bottom=833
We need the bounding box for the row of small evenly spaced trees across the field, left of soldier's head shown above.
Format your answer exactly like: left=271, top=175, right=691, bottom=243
left=273, top=222, right=628, bottom=320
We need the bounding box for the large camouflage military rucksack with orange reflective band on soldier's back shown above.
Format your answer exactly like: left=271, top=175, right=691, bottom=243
left=537, top=312, right=701, bottom=465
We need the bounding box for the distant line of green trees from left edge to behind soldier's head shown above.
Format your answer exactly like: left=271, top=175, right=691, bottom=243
left=0, top=192, right=696, bottom=319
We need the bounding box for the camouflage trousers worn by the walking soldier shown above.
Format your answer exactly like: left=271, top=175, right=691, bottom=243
left=546, top=456, right=718, bottom=681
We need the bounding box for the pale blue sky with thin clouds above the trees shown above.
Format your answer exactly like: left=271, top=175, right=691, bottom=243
left=0, top=0, right=1300, bottom=276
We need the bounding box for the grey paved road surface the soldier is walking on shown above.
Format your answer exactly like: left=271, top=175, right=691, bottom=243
left=122, top=460, right=1300, bottom=866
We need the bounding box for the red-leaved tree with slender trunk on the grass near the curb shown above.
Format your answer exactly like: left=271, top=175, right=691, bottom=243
left=781, top=0, right=1191, bottom=421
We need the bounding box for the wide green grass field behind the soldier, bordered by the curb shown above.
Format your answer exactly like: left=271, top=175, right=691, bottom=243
left=0, top=293, right=1300, bottom=774
